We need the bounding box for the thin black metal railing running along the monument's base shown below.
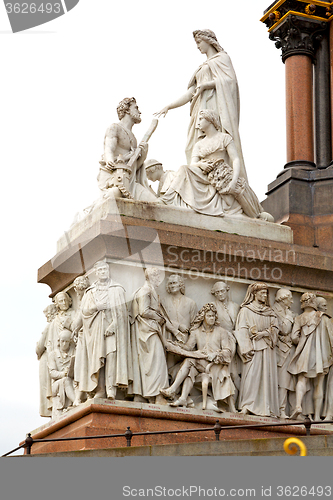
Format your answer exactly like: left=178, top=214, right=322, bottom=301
left=2, top=417, right=333, bottom=457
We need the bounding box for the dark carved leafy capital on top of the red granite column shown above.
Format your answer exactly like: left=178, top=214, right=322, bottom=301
left=269, top=15, right=328, bottom=62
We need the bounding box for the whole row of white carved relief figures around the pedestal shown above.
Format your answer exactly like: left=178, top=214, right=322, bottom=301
left=38, top=261, right=333, bottom=426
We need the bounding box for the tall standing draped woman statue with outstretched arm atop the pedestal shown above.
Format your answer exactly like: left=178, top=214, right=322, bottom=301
left=157, top=30, right=247, bottom=180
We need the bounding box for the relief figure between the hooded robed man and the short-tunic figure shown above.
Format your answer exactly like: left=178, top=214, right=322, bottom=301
left=272, top=288, right=296, bottom=418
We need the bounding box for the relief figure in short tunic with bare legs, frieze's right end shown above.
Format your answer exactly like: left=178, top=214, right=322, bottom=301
left=289, top=292, right=333, bottom=420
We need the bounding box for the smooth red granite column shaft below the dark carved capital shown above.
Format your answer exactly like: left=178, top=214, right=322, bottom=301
left=285, top=55, right=314, bottom=162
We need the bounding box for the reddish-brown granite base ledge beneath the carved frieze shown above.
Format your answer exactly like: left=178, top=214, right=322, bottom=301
left=22, top=399, right=333, bottom=454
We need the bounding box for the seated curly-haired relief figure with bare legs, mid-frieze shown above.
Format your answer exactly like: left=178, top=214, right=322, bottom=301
left=161, top=303, right=236, bottom=412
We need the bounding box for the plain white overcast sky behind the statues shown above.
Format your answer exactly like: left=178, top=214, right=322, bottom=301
left=0, top=0, right=285, bottom=454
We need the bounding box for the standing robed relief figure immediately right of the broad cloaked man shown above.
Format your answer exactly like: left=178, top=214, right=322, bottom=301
left=131, top=268, right=169, bottom=404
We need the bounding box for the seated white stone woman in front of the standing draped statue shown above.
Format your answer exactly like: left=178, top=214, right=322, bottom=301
left=160, top=110, right=271, bottom=220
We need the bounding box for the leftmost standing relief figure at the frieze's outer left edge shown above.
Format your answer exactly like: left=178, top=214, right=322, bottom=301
left=36, top=304, right=58, bottom=417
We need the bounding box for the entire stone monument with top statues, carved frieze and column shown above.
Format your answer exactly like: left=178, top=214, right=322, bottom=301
left=29, top=22, right=333, bottom=452
